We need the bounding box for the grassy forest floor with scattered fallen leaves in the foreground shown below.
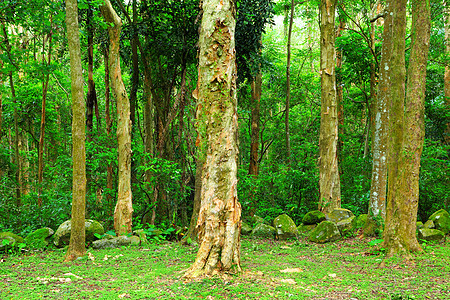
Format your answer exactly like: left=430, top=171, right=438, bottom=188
left=0, top=238, right=450, bottom=300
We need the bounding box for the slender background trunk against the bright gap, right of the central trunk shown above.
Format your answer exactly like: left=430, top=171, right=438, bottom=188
left=284, top=0, right=295, bottom=168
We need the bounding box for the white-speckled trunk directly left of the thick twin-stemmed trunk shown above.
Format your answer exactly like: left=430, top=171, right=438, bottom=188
left=367, top=0, right=393, bottom=227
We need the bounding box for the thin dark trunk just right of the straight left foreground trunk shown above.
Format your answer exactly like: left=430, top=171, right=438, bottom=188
left=86, top=5, right=98, bottom=136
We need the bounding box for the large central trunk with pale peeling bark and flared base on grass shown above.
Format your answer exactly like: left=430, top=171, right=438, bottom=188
left=184, top=0, right=241, bottom=278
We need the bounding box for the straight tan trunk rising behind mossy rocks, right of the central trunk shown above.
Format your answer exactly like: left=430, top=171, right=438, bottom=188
left=319, top=0, right=341, bottom=212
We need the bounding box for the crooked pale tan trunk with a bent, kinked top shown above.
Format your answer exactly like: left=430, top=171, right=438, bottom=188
left=100, top=0, right=133, bottom=235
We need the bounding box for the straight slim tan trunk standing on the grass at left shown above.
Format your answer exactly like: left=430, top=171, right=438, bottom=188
left=65, top=0, right=86, bottom=261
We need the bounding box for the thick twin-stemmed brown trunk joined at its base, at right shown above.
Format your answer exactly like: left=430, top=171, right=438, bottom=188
left=384, top=0, right=430, bottom=256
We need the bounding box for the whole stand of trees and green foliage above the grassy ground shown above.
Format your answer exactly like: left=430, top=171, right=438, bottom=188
left=0, top=0, right=450, bottom=299
